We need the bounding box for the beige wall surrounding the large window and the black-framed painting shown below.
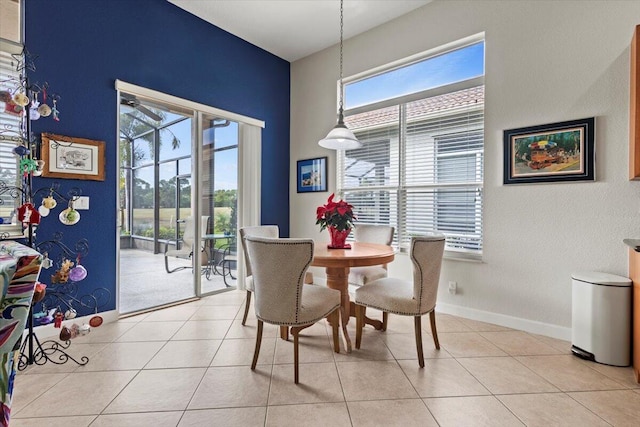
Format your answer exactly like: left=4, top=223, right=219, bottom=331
left=290, top=1, right=640, bottom=339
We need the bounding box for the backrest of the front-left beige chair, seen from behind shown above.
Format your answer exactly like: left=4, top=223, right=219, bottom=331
left=245, top=236, right=313, bottom=324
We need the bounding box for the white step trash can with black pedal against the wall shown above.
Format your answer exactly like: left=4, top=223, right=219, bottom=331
left=571, top=272, right=633, bottom=366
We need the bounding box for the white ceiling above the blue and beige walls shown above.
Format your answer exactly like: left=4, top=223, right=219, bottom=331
left=168, top=0, right=432, bottom=62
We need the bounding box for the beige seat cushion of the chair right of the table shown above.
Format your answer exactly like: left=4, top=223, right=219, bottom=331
left=355, top=277, right=433, bottom=316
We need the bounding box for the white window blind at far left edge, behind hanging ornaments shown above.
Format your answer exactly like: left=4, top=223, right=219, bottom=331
left=0, top=46, right=22, bottom=227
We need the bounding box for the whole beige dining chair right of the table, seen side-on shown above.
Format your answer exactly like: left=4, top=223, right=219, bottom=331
left=355, top=234, right=445, bottom=368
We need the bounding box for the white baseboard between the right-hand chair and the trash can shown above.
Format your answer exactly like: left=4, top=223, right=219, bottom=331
left=436, top=303, right=571, bottom=341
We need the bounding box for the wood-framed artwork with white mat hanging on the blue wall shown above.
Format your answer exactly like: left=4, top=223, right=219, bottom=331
left=40, top=133, right=105, bottom=181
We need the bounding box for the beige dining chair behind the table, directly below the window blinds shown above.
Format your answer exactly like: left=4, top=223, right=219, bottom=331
left=349, top=224, right=395, bottom=331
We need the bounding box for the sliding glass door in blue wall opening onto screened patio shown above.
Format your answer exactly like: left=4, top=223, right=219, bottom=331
left=116, top=81, right=264, bottom=314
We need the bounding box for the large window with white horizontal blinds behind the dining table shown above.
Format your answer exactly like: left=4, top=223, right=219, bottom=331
left=337, top=42, right=484, bottom=258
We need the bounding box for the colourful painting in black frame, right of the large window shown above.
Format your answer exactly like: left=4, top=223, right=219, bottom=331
left=504, top=117, right=595, bottom=184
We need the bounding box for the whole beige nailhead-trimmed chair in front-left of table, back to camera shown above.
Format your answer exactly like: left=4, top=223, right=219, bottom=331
left=244, top=236, right=340, bottom=384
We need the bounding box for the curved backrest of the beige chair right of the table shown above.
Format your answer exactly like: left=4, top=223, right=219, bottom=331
left=410, top=233, right=445, bottom=312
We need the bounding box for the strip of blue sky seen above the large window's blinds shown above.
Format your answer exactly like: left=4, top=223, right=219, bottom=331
left=344, top=42, right=484, bottom=109
